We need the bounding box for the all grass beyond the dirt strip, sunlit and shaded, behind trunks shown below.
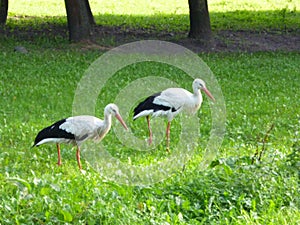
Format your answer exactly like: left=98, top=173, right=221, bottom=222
left=7, top=0, right=300, bottom=32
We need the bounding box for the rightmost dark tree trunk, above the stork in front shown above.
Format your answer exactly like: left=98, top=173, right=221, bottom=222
left=189, top=0, right=212, bottom=41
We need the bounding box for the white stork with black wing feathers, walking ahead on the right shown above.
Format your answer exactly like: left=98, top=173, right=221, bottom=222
left=133, top=79, right=215, bottom=151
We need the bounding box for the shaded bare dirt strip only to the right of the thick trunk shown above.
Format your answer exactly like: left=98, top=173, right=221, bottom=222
left=93, top=27, right=300, bottom=52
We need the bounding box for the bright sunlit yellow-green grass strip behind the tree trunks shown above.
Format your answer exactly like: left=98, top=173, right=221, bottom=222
left=9, top=0, right=299, bottom=16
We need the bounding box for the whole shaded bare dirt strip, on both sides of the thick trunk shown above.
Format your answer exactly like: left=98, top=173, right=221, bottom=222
left=0, top=24, right=300, bottom=53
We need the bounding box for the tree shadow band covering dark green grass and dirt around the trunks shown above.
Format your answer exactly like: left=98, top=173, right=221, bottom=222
left=0, top=10, right=300, bottom=52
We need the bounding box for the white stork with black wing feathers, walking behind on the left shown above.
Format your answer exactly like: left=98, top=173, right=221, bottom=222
left=33, top=103, right=128, bottom=169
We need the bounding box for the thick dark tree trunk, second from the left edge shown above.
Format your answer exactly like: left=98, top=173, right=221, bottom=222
left=65, top=0, right=95, bottom=42
